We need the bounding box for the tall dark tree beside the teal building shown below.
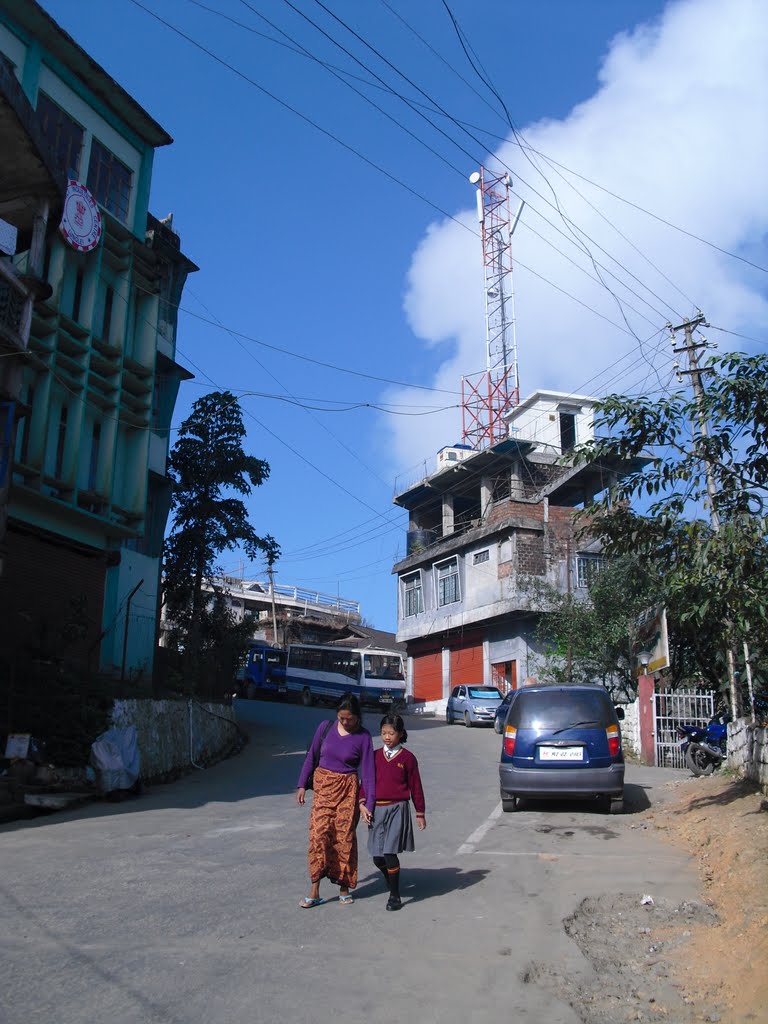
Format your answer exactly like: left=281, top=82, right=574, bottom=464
left=164, top=391, right=280, bottom=692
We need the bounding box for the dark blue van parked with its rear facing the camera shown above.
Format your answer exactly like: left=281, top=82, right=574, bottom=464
left=499, top=685, right=624, bottom=813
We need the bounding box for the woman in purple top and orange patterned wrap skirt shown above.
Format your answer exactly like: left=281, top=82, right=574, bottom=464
left=296, top=693, right=376, bottom=910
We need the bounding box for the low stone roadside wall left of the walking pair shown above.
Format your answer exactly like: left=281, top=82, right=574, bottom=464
left=112, top=700, right=240, bottom=781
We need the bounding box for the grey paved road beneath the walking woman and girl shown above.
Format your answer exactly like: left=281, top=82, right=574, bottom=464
left=0, top=701, right=695, bottom=1024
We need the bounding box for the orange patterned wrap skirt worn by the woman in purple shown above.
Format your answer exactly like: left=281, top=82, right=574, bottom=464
left=309, top=768, right=360, bottom=889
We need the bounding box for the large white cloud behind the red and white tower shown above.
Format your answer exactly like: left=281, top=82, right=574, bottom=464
left=387, top=0, right=768, bottom=479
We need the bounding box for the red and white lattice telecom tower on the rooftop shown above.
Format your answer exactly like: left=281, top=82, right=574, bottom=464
left=462, top=167, right=523, bottom=451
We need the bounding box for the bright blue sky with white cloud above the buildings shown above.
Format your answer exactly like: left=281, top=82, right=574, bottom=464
left=42, top=0, right=768, bottom=629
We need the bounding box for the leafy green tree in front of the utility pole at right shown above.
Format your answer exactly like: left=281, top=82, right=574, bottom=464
left=579, top=353, right=768, bottom=715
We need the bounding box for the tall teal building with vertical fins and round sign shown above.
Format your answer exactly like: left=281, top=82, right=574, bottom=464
left=0, top=0, right=197, bottom=675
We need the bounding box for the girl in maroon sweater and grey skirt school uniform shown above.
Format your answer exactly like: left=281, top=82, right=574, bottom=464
left=360, top=715, right=427, bottom=910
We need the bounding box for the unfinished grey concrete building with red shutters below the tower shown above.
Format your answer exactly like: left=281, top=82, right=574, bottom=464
left=393, top=391, right=627, bottom=710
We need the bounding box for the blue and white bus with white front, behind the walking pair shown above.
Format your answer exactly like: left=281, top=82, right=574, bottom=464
left=286, top=643, right=406, bottom=708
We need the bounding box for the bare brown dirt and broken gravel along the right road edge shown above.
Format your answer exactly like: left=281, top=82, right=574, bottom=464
left=522, top=775, right=768, bottom=1024
